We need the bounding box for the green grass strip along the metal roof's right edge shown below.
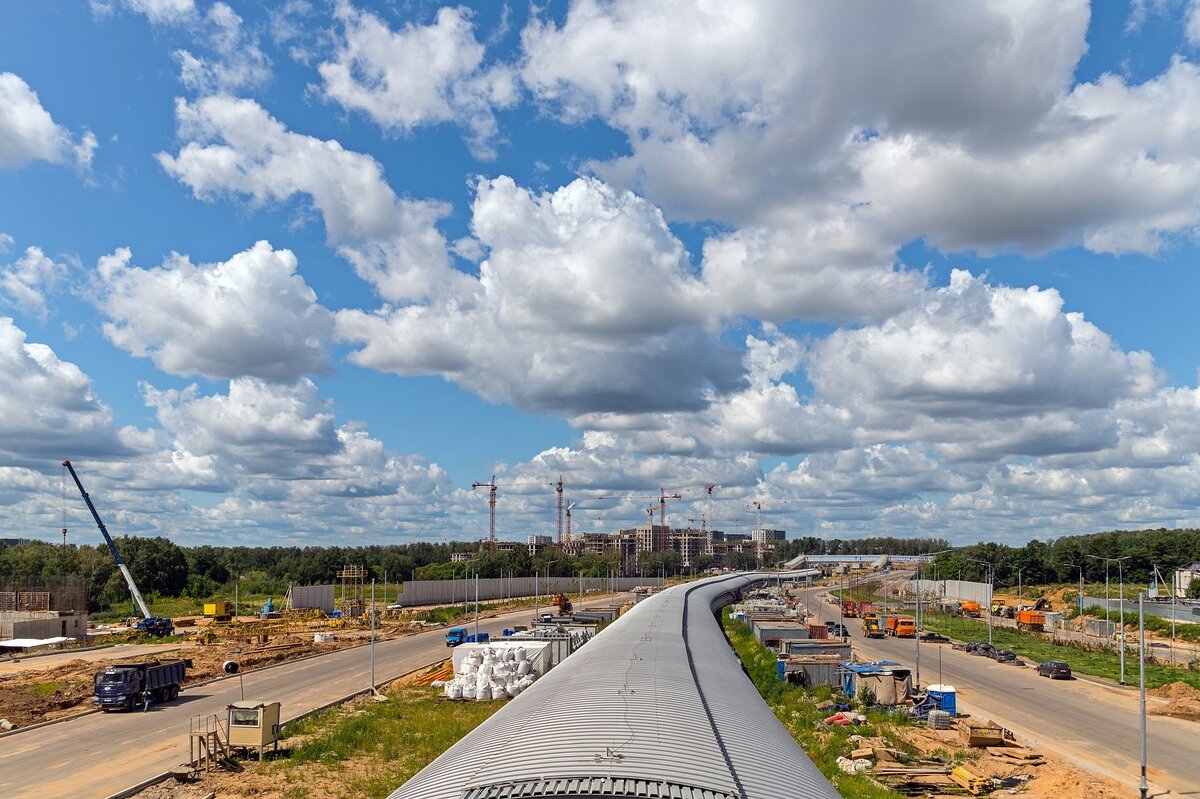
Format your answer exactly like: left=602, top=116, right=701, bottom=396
left=720, top=614, right=908, bottom=799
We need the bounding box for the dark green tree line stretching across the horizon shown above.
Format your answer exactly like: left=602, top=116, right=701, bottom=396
left=0, top=529, right=1200, bottom=611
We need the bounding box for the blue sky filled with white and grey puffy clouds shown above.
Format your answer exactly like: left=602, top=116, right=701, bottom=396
left=0, top=0, right=1200, bottom=543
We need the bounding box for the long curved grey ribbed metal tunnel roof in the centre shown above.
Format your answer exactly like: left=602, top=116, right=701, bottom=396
left=390, top=572, right=839, bottom=799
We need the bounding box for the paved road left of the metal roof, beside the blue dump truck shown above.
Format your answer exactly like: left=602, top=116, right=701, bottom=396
left=0, top=597, right=611, bottom=799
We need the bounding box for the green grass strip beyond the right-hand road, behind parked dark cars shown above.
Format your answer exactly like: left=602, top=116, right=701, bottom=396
left=920, top=612, right=1200, bottom=687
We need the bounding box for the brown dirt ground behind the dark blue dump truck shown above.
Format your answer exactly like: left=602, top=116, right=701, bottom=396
left=0, top=623, right=422, bottom=727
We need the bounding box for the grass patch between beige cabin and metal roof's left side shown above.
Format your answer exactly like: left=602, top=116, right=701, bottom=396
left=260, top=687, right=504, bottom=797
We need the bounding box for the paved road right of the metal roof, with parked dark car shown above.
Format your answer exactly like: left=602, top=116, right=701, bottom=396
left=809, top=588, right=1200, bottom=797
